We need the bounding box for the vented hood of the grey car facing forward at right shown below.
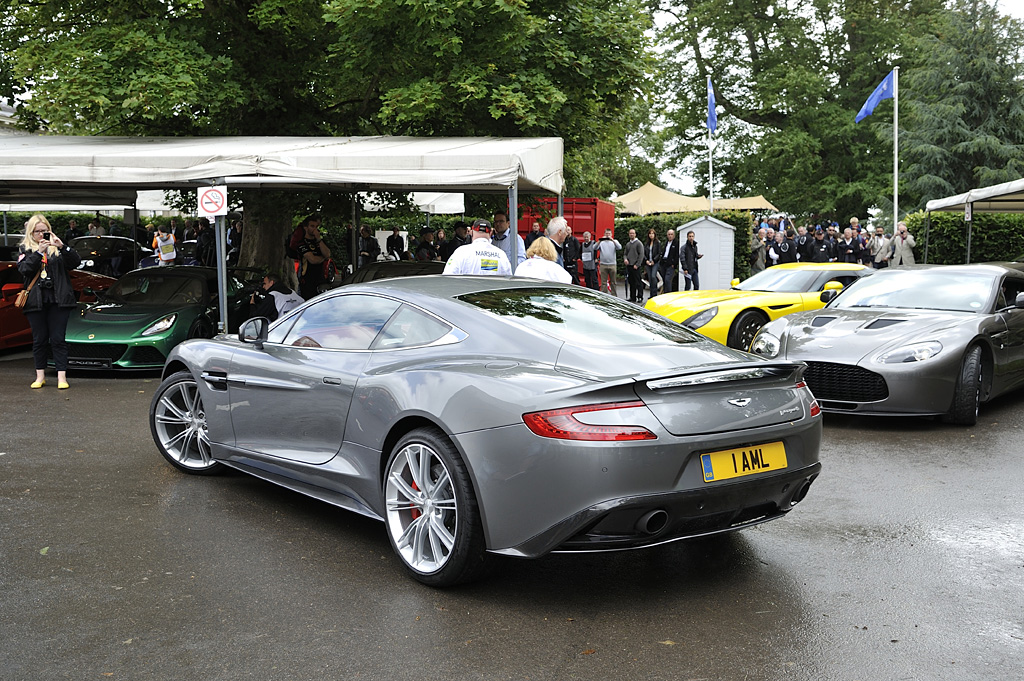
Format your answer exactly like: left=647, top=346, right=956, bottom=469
left=784, top=307, right=979, bottom=361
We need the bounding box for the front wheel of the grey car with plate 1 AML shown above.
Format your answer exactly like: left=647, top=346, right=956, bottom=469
left=154, top=380, right=217, bottom=470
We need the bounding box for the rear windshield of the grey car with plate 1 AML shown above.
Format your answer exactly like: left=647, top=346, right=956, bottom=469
left=459, top=288, right=702, bottom=347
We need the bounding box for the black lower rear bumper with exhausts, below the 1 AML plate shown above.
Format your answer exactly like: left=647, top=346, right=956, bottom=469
left=495, top=463, right=821, bottom=558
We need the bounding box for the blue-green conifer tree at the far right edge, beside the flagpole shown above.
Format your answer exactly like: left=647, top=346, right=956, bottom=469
left=900, top=0, right=1024, bottom=210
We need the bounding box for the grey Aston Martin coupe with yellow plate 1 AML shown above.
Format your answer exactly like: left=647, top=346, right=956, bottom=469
left=150, top=275, right=821, bottom=586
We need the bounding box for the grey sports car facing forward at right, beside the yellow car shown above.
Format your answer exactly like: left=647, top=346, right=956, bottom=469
left=751, top=263, right=1024, bottom=425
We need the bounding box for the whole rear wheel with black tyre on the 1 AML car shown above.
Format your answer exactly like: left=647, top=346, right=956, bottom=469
left=381, top=427, right=489, bottom=587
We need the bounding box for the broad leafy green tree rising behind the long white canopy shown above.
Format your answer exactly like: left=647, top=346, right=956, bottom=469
left=0, top=0, right=650, bottom=263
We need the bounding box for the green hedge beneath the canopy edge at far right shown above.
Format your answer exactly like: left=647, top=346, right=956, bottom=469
left=905, top=211, right=1024, bottom=265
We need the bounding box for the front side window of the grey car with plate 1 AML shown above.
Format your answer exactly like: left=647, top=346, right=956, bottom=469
left=285, top=295, right=400, bottom=350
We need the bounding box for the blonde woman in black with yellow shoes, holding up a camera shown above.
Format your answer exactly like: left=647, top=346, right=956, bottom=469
left=17, top=213, right=82, bottom=390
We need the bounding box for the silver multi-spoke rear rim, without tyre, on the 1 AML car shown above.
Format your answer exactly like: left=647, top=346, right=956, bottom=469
left=384, top=442, right=459, bottom=573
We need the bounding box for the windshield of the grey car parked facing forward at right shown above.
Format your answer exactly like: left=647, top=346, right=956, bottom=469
left=830, top=268, right=995, bottom=312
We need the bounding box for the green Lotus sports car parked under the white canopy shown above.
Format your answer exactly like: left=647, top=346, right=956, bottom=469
left=66, top=266, right=254, bottom=370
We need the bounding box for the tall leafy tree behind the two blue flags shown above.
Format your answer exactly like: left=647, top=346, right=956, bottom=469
left=663, top=0, right=941, bottom=221
